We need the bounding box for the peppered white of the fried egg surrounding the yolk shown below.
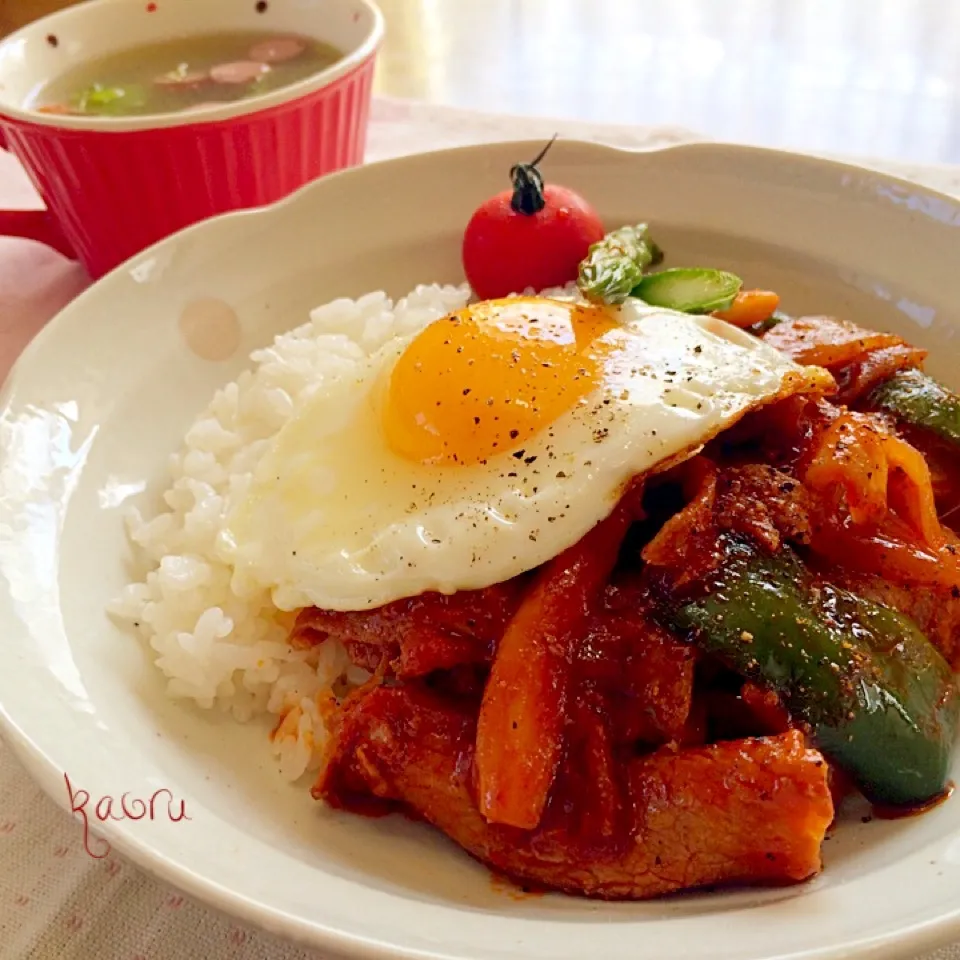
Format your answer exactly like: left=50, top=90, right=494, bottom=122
left=225, top=301, right=832, bottom=610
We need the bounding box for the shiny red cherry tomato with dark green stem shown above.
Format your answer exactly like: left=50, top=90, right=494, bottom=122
left=463, top=140, right=604, bottom=300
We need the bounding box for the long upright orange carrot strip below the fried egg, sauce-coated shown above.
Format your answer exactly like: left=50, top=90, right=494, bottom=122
left=476, top=494, right=635, bottom=830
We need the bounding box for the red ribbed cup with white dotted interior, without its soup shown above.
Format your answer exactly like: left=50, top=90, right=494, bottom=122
left=0, top=0, right=383, bottom=277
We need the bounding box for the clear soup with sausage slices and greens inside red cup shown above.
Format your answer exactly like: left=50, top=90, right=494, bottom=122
left=30, top=31, right=342, bottom=117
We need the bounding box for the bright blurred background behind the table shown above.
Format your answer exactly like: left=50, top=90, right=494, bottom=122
left=7, top=0, right=960, bottom=163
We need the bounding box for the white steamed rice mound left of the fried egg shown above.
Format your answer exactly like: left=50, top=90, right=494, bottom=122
left=110, top=285, right=470, bottom=780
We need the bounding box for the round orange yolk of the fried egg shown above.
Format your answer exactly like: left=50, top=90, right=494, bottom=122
left=384, top=297, right=616, bottom=465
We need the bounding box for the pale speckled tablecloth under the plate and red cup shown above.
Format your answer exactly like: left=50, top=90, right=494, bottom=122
left=0, top=100, right=960, bottom=960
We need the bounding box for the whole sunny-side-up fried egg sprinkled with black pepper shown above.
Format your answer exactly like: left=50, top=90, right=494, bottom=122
left=226, top=297, right=833, bottom=610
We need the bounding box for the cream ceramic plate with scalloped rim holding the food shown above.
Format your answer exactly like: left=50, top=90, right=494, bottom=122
left=0, top=142, right=960, bottom=960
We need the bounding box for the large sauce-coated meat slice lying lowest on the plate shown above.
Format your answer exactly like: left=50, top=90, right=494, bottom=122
left=314, top=684, right=833, bottom=899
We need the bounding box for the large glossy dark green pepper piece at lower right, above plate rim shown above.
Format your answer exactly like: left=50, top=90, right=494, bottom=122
left=672, top=540, right=960, bottom=806
